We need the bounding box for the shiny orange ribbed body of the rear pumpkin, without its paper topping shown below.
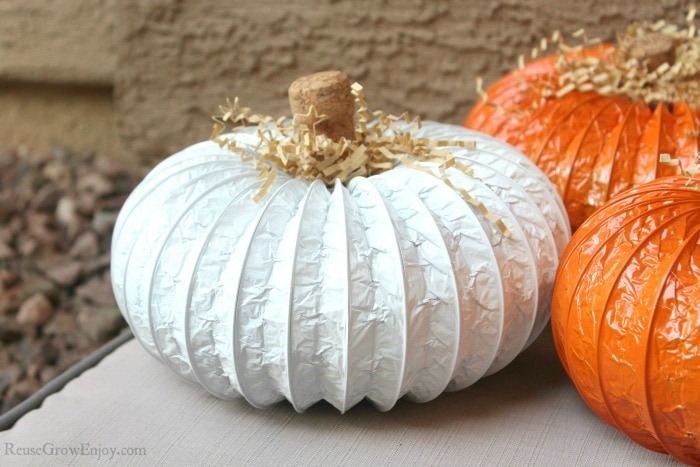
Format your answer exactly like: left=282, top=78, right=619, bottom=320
left=464, top=48, right=700, bottom=229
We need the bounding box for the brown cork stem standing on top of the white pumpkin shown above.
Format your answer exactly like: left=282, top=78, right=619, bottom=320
left=289, top=71, right=355, bottom=141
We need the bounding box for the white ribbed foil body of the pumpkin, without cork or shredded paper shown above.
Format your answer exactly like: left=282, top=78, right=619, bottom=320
left=112, top=118, right=570, bottom=412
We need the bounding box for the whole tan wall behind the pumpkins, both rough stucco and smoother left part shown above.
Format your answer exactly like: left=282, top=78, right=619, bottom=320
left=0, top=0, right=686, bottom=165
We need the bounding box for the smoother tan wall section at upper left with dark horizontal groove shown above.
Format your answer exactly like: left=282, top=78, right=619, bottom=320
left=0, top=0, right=136, bottom=160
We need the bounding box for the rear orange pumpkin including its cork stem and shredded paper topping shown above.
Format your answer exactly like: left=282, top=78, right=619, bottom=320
left=464, top=19, right=700, bottom=229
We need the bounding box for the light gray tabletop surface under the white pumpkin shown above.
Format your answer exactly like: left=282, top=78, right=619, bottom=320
left=0, top=329, right=678, bottom=466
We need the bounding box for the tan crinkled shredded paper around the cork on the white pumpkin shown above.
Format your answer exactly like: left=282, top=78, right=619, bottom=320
left=210, top=83, right=511, bottom=237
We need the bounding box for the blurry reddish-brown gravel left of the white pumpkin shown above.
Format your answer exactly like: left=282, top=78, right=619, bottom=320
left=0, top=148, right=141, bottom=413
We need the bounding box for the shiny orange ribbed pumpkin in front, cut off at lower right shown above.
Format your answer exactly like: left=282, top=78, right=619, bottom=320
left=552, top=177, right=700, bottom=464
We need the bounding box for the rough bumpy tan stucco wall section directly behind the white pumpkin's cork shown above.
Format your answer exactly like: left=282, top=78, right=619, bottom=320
left=116, top=0, right=686, bottom=163
